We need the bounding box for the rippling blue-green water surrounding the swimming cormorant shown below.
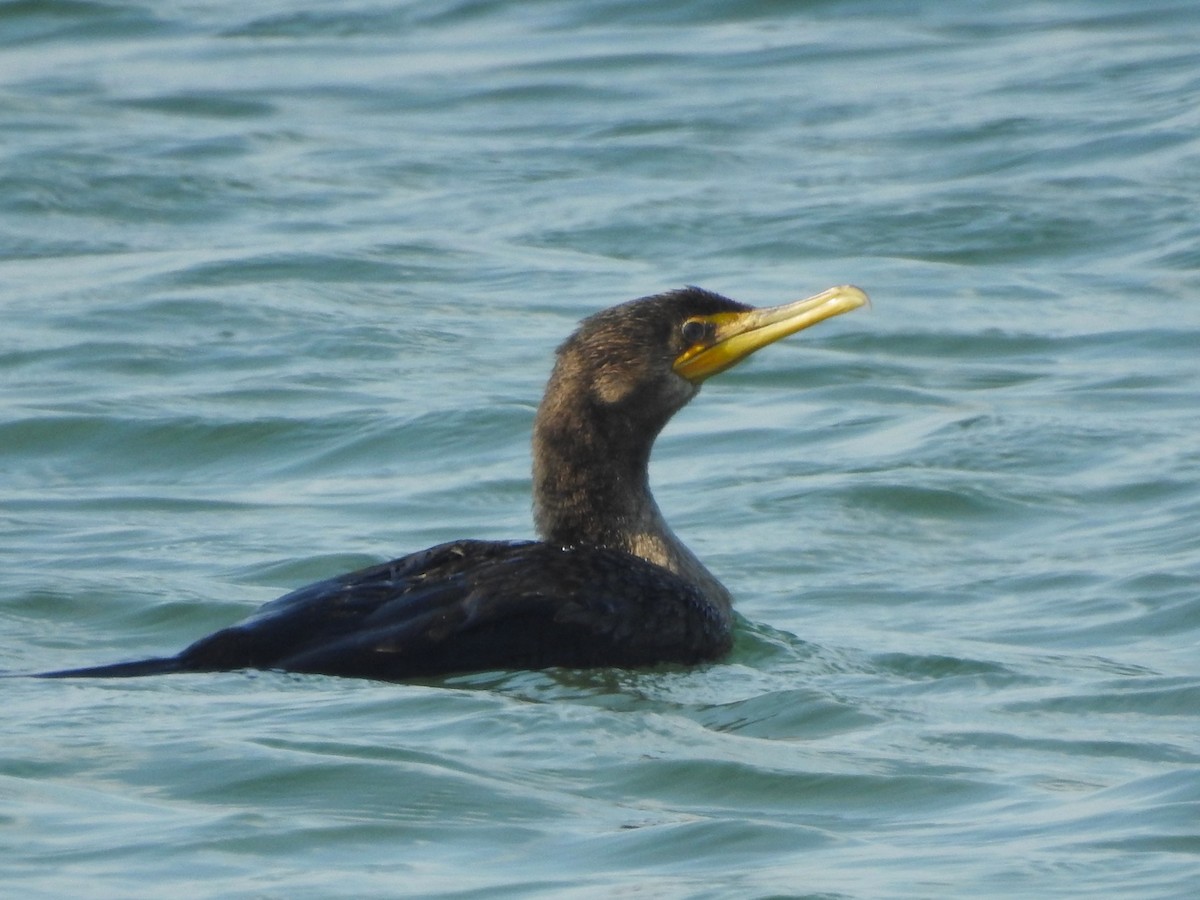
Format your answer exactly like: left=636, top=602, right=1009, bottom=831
left=0, top=0, right=1200, bottom=898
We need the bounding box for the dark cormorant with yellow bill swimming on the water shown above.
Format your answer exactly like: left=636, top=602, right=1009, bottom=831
left=37, top=286, right=866, bottom=680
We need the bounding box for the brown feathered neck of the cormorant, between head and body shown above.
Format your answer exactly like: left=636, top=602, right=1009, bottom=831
left=533, top=380, right=731, bottom=610
